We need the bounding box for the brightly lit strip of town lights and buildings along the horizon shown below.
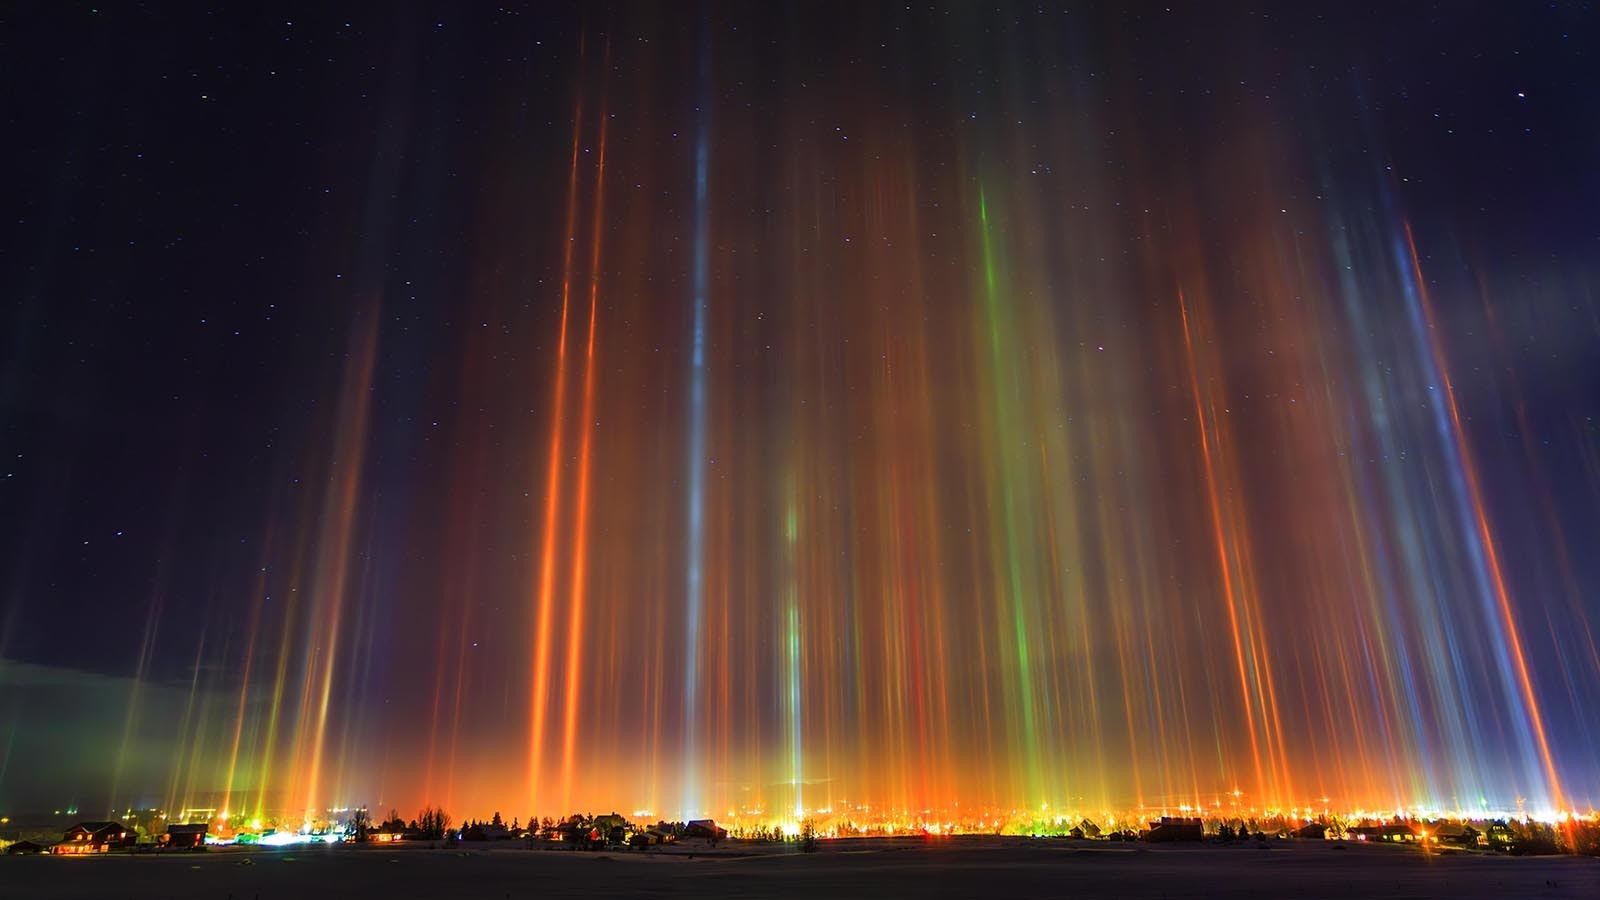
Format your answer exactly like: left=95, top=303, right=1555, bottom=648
left=6, top=798, right=1600, bottom=855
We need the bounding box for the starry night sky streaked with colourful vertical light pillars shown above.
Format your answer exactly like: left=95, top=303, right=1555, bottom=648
left=0, top=2, right=1600, bottom=817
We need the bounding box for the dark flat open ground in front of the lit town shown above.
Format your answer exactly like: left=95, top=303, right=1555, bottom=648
left=0, top=838, right=1600, bottom=900
